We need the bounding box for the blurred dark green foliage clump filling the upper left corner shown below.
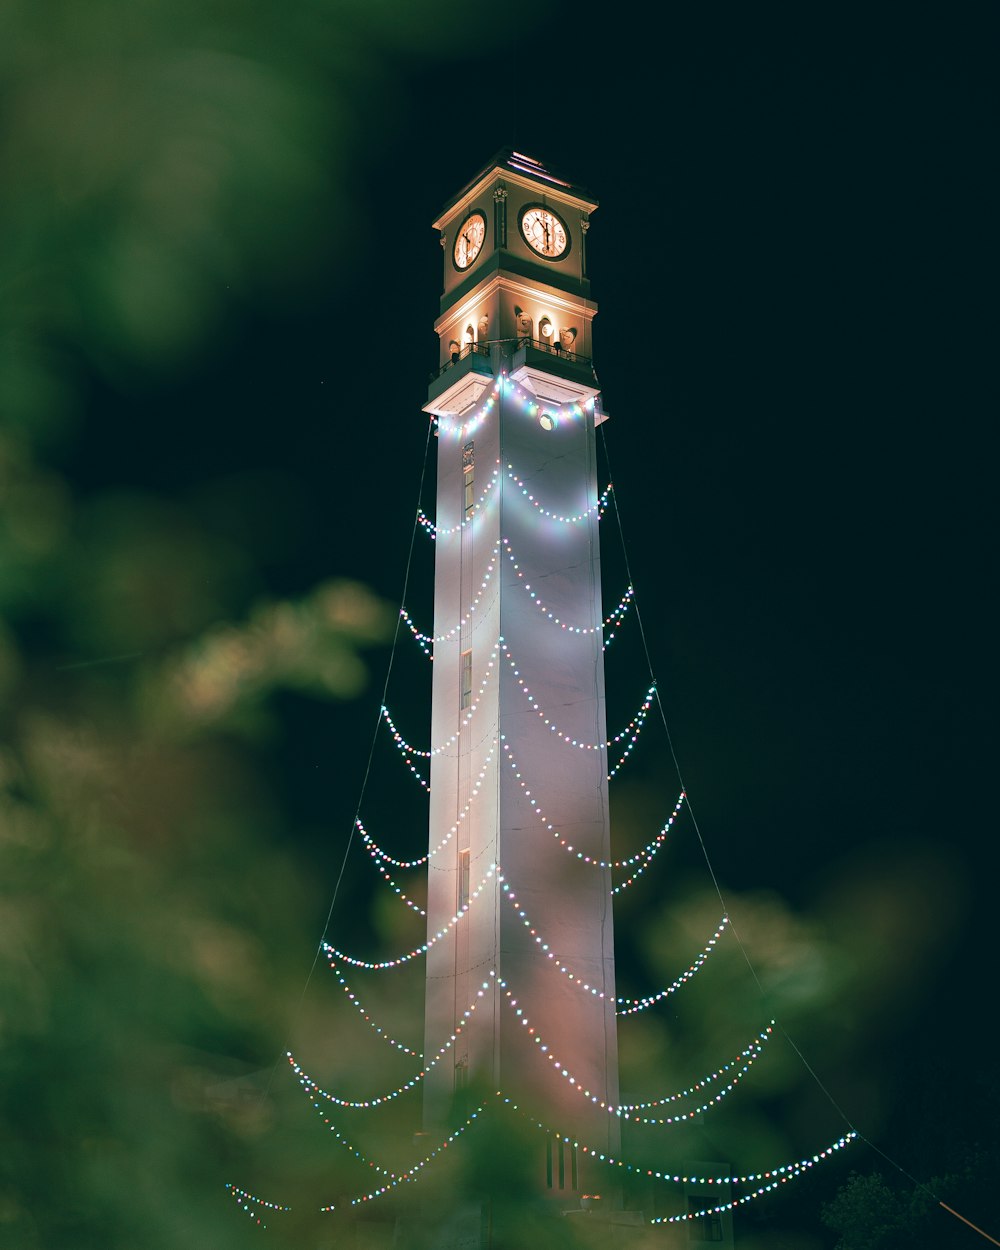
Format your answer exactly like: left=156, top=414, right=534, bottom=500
left=0, top=0, right=480, bottom=400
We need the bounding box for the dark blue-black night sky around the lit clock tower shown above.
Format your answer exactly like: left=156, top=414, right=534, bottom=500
left=71, top=6, right=996, bottom=1241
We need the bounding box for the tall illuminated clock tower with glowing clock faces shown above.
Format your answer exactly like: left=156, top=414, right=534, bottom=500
left=424, top=150, right=620, bottom=1205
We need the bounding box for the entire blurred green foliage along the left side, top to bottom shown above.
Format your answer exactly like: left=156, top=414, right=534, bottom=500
left=0, top=0, right=500, bottom=1250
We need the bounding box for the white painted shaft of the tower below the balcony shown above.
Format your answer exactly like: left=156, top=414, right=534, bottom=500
left=425, top=354, right=619, bottom=1170
